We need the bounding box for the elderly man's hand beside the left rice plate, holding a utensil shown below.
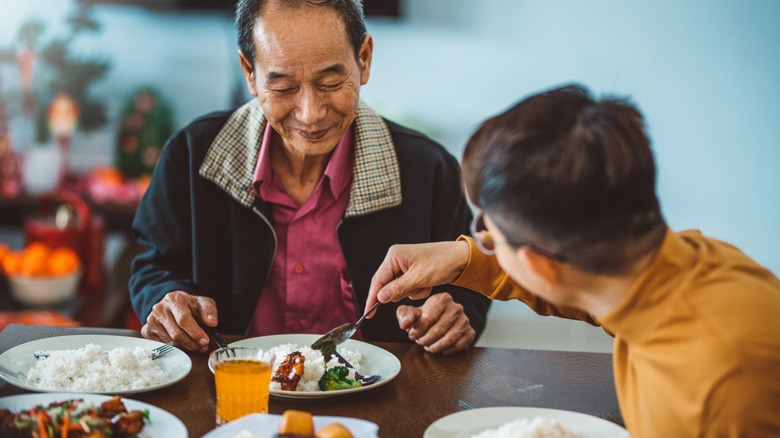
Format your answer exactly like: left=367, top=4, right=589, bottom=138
left=141, top=291, right=217, bottom=352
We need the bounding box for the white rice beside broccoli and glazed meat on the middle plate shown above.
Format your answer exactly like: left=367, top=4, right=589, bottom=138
left=269, top=344, right=363, bottom=392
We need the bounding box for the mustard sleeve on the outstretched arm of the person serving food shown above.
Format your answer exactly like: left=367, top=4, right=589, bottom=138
left=453, top=236, right=599, bottom=325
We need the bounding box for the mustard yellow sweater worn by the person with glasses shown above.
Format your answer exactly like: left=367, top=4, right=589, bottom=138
left=455, top=231, right=780, bottom=438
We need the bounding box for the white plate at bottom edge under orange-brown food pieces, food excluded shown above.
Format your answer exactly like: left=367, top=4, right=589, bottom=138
left=203, top=414, right=379, bottom=438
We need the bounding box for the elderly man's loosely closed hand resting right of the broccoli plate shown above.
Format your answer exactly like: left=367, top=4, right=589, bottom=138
left=396, top=293, right=476, bottom=355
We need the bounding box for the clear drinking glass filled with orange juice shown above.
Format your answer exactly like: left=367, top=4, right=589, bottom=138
left=209, top=347, right=274, bottom=425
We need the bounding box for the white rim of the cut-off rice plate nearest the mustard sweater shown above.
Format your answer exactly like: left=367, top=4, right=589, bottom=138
left=423, top=406, right=629, bottom=438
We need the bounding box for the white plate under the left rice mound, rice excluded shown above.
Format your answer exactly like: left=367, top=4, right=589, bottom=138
left=0, top=335, right=192, bottom=395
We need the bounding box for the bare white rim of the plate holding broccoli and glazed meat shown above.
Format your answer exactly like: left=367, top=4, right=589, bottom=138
left=224, top=333, right=401, bottom=399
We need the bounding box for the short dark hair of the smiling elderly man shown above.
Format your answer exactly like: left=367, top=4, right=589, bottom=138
left=236, top=0, right=368, bottom=66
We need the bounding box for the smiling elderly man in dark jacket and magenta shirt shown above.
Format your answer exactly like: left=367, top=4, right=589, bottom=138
left=130, top=0, right=489, bottom=354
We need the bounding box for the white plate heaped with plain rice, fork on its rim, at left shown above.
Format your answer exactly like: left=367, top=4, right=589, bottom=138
left=0, top=335, right=192, bottom=395
